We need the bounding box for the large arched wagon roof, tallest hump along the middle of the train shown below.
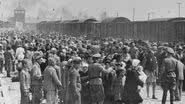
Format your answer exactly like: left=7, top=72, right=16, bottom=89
left=101, top=17, right=131, bottom=23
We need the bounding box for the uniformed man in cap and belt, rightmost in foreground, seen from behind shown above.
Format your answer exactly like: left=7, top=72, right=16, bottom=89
left=161, top=47, right=177, bottom=104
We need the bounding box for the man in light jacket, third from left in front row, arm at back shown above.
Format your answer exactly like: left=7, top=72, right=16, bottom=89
left=43, top=57, right=62, bottom=104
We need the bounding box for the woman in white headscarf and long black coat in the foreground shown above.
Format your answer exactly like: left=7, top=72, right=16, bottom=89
left=122, top=59, right=144, bottom=104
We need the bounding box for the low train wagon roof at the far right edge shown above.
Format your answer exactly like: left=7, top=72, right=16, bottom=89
left=149, top=17, right=185, bottom=22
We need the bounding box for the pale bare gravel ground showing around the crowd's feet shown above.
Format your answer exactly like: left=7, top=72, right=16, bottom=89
left=0, top=75, right=185, bottom=104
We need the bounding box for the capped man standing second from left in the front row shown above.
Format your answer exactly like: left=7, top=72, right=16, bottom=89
left=31, top=51, right=42, bottom=104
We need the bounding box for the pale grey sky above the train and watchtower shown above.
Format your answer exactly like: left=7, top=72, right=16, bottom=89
left=0, top=0, right=185, bottom=20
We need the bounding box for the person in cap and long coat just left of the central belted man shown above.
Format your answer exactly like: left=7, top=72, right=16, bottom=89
left=65, top=57, right=81, bottom=104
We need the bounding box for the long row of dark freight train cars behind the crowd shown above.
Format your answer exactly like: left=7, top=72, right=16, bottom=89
left=38, top=17, right=185, bottom=42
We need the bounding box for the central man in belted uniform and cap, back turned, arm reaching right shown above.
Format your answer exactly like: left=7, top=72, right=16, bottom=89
left=88, top=53, right=109, bottom=104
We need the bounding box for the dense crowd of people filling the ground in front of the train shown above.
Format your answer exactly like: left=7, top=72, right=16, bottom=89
left=0, top=32, right=185, bottom=104
